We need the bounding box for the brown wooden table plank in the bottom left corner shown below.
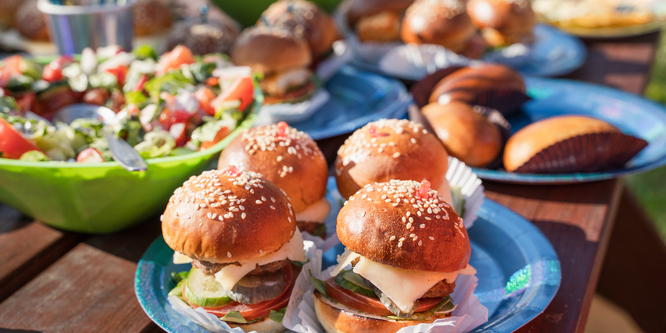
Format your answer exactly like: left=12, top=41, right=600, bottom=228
left=0, top=244, right=154, bottom=332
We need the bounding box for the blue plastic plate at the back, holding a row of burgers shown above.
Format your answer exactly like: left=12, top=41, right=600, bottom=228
left=352, top=24, right=587, bottom=81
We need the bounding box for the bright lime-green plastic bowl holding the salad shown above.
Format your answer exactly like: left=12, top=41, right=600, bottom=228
left=0, top=93, right=263, bottom=234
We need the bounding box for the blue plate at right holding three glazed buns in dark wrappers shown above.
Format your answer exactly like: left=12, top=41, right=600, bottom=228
left=473, top=77, right=666, bottom=184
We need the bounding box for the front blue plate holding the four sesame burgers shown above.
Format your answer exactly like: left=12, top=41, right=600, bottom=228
left=134, top=199, right=561, bottom=332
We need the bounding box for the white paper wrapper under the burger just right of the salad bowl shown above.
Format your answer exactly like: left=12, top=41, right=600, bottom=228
left=254, top=88, right=331, bottom=126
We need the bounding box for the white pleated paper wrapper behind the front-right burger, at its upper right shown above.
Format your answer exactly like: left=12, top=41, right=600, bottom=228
left=446, top=156, right=486, bottom=229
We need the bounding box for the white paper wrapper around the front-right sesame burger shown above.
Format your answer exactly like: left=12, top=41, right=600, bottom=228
left=282, top=266, right=488, bottom=333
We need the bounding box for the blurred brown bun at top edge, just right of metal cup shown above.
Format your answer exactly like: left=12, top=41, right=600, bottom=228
left=132, top=0, right=173, bottom=36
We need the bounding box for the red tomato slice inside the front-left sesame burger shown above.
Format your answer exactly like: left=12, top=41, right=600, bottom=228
left=183, top=265, right=300, bottom=320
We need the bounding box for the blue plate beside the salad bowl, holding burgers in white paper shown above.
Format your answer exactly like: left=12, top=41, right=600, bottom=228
left=289, top=66, right=412, bottom=140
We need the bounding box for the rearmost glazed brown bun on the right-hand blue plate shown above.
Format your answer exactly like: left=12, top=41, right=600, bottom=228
left=429, top=63, right=525, bottom=104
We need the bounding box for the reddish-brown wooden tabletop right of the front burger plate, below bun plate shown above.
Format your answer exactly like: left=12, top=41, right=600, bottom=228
left=484, top=180, right=622, bottom=332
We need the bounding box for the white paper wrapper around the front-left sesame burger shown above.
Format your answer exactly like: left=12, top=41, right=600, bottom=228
left=168, top=240, right=321, bottom=333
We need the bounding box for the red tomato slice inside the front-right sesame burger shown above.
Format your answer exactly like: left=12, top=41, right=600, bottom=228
left=326, top=277, right=442, bottom=316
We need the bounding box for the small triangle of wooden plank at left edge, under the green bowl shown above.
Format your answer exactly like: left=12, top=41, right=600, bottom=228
left=0, top=204, right=82, bottom=302
